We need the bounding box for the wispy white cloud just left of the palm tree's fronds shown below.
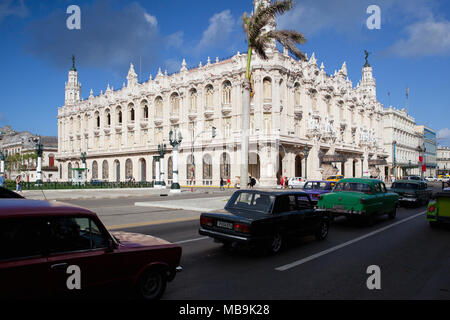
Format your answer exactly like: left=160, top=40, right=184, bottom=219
left=196, top=10, right=236, bottom=51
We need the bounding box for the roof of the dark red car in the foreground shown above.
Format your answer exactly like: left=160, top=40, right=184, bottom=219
left=0, top=199, right=95, bottom=218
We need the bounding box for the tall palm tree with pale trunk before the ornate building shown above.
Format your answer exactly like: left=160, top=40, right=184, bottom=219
left=241, top=0, right=306, bottom=187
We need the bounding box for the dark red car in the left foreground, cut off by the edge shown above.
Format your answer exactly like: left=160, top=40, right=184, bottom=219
left=0, top=199, right=182, bottom=299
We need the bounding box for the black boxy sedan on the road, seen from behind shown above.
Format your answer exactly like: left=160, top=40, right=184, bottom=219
left=199, top=190, right=330, bottom=253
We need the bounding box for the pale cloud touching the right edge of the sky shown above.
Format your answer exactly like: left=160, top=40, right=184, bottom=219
left=388, top=19, right=450, bottom=57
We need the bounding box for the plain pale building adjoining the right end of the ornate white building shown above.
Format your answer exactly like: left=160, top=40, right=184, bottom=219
left=383, top=106, right=420, bottom=178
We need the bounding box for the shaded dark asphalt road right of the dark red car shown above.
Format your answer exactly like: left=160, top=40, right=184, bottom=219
left=117, top=207, right=450, bottom=300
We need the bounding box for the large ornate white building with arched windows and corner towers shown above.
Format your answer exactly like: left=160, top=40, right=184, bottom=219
left=57, top=1, right=388, bottom=186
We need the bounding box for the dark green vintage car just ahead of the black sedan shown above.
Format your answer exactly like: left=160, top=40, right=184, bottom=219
left=317, top=178, right=399, bottom=224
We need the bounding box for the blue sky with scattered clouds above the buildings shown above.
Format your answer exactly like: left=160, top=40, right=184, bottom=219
left=0, top=0, right=450, bottom=145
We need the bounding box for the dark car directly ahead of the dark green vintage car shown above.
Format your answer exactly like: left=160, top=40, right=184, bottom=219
left=390, top=180, right=433, bottom=205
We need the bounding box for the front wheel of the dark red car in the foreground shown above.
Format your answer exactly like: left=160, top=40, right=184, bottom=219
left=136, top=269, right=167, bottom=300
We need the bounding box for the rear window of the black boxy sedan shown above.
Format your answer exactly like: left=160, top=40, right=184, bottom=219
left=226, top=192, right=275, bottom=214
